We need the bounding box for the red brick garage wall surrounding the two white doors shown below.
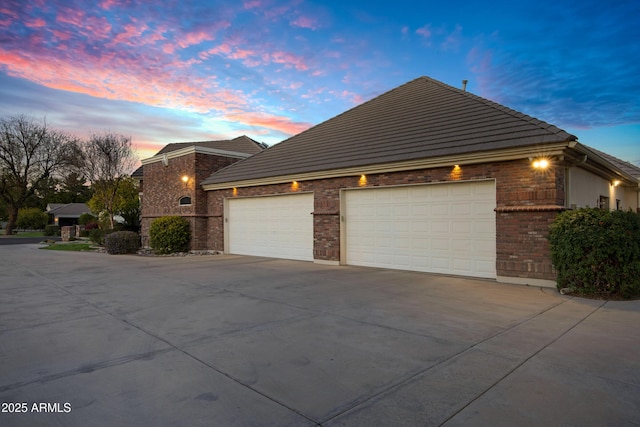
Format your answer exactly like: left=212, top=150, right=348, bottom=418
left=207, top=160, right=565, bottom=280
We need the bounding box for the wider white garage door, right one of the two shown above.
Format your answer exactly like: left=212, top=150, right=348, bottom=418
left=344, top=181, right=496, bottom=278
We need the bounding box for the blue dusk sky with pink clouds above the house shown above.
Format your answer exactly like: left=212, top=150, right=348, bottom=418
left=0, top=0, right=640, bottom=165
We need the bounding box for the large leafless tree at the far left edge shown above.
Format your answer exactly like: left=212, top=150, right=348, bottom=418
left=0, top=115, right=79, bottom=234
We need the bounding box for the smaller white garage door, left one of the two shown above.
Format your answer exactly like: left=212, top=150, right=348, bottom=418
left=227, top=193, right=313, bottom=261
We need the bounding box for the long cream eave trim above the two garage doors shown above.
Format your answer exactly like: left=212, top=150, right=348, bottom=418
left=202, top=142, right=568, bottom=191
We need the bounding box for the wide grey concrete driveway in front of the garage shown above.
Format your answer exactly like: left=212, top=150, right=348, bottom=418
left=0, top=245, right=640, bottom=426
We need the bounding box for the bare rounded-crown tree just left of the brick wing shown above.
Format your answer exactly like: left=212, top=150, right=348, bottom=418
left=83, top=133, right=136, bottom=228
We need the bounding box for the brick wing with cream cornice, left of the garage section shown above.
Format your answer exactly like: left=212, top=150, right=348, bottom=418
left=132, top=136, right=265, bottom=249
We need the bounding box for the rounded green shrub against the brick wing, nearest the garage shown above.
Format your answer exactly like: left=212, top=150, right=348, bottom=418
left=149, top=216, right=191, bottom=254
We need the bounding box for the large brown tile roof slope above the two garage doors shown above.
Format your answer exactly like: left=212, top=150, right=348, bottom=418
left=203, top=77, right=577, bottom=185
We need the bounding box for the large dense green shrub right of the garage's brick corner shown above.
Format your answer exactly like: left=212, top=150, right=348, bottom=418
left=549, top=208, right=640, bottom=298
